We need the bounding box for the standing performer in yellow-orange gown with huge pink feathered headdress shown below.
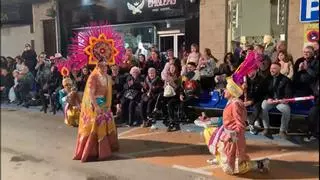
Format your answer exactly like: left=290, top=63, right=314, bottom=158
left=56, top=24, right=124, bottom=162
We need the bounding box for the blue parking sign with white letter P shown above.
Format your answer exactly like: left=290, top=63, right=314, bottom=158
left=300, top=0, right=319, bottom=23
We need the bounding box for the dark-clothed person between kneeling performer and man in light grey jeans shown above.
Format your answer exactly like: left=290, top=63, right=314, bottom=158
left=244, top=71, right=265, bottom=134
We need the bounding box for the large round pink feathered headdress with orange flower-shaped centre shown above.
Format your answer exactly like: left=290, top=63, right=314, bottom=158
left=57, top=23, right=125, bottom=71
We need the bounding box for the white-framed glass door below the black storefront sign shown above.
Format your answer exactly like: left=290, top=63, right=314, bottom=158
left=158, top=32, right=185, bottom=57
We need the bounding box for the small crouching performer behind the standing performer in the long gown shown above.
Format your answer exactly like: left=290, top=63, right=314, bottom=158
left=58, top=67, right=81, bottom=127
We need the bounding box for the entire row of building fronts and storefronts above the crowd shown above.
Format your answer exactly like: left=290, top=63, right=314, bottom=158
left=1, top=0, right=319, bottom=60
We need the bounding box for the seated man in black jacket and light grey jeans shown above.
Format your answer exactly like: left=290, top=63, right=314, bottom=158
left=261, top=62, right=292, bottom=138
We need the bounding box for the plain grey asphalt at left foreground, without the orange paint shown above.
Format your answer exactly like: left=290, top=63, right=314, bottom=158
left=1, top=109, right=212, bottom=180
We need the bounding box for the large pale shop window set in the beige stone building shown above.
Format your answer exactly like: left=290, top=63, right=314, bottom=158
left=227, top=0, right=288, bottom=51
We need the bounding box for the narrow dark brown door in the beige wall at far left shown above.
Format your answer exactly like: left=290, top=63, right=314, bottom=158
left=42, top=19, right=57, bottom=56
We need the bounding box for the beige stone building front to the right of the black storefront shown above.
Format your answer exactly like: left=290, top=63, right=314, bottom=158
left=200, top=0, right=319, bottom=60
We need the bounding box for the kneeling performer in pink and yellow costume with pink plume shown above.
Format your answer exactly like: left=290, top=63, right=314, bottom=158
left=202, top=51, right=269, bottom=175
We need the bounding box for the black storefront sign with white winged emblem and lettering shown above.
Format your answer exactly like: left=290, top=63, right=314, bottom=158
left=64, top=0, right=186, bottom=27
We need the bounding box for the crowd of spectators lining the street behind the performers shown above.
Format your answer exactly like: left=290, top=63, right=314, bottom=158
left=1, top=41, right=319, bottom=137
